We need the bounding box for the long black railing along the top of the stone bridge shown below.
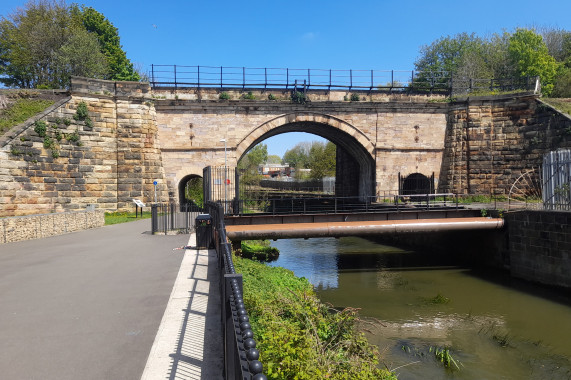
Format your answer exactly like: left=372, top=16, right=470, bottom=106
left=149, top=64, right=539, bottom=95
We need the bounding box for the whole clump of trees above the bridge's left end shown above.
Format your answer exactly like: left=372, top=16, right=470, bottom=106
left=0, top=0, right=139, bottom=88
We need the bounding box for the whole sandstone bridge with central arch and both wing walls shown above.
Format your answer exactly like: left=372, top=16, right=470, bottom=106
left=0, top=78, right=571, bottom=216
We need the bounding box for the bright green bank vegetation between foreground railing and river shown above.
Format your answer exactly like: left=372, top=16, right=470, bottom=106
left=235, top=257, right=396, bottom=380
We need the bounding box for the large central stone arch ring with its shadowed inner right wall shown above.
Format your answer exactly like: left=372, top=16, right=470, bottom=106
left=237, top=113, right=375, bottom=201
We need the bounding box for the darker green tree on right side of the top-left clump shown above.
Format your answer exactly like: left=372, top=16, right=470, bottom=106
left=72, top=5, right=141, bottom=81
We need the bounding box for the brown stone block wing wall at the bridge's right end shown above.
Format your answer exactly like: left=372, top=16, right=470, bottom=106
left=440, top=95, right=571, bottom=195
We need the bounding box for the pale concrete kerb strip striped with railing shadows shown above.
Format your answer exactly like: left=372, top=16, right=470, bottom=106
left=141, top=233, right=224, bottom=380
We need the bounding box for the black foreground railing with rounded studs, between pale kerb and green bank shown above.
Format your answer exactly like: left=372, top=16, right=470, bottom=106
left=206, top=202, right=267, bottom=380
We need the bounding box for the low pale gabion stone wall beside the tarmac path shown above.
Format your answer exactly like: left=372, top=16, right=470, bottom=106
left=0, top=210, right=105, bottom=243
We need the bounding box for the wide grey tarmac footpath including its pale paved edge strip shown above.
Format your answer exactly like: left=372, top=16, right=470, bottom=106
left=0, top=219, right=222, bottom=380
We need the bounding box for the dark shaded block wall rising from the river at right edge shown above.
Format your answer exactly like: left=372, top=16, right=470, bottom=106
left=506, top=211, right=571, bottom=288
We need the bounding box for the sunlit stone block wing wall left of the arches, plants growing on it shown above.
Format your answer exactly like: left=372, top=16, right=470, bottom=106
left=0, top=78, right=168, bottom=216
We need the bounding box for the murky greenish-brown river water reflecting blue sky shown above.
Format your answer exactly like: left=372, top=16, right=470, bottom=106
left=271, top=238, right=571, bottom=380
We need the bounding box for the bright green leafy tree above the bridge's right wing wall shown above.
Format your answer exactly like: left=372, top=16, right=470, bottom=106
left=508, top=28, right=559, bottom=95
